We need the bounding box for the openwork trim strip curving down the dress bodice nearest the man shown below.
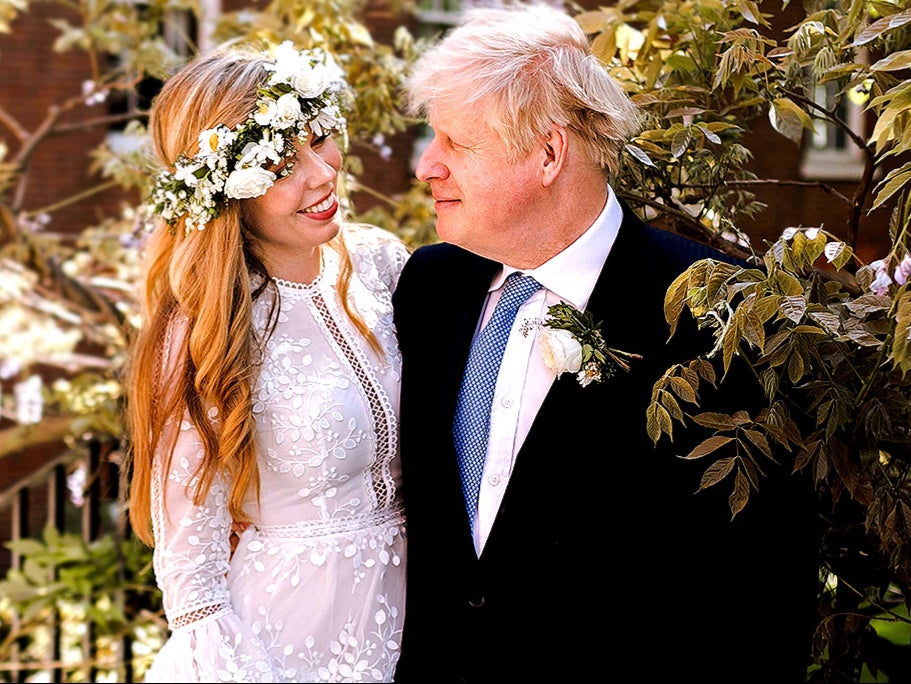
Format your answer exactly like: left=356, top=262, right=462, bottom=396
left=312, top=292, right=398, bottom=508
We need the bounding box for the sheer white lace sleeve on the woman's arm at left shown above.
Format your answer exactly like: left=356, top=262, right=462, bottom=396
left=145, top=326, right=278, bottom=682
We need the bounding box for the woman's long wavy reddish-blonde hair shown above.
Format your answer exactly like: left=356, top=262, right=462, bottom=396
left=125, top=46, right=381, bottom=545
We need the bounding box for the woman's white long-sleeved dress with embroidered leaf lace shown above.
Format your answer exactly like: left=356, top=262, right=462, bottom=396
left=146, top=226, right=407, bottom=682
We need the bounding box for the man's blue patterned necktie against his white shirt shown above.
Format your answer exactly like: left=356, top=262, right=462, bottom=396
left=452, top=273, right=541, bottom=529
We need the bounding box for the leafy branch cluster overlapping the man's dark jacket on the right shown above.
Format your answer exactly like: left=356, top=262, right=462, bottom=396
left=646, top=216, right=911, bottom=676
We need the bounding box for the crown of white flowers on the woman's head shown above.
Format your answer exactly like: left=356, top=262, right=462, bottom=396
left=148, top=41, right=348, bottom=234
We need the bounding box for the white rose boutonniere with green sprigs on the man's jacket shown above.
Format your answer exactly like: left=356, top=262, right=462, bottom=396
left=521, top=302, right=642, bottom=387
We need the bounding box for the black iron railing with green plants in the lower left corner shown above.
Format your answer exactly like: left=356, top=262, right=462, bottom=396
left=0, top=442, right=156, bottom=682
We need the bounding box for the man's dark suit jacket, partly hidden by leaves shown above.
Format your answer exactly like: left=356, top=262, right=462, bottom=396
left=394, top=200, right=818, bottom=684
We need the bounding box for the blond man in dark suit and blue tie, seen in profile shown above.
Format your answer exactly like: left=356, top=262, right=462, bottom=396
left=394, top=5, right=817, bottom=684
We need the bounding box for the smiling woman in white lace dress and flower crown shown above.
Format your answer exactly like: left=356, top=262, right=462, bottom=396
left=127, top=42, right=407, bottom=682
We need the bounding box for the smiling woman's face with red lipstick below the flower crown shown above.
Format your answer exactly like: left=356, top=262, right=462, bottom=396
left=240, top=133, right=342, bottom=282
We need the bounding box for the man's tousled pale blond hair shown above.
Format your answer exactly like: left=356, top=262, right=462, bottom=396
left=405, top=3, right=640, bottom=173
